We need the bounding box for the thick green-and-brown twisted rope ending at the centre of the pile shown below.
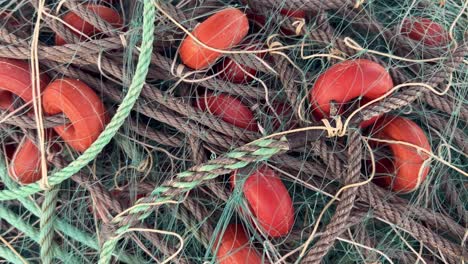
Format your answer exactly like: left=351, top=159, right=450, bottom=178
left=99, top=135, right=289, bottom=264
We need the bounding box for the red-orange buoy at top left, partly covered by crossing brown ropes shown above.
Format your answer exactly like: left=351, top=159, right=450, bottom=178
left=55, top=5, right=123, bottom=46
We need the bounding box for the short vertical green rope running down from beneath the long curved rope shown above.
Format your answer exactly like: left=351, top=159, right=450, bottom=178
left=39, top=185, right=60, bottom=264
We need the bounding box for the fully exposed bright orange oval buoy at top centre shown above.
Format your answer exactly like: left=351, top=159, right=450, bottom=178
left=180, top=8, right=249, bottom=70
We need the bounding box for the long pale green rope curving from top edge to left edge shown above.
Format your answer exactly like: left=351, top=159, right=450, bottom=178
left=0, top=0, right=155, bottom=201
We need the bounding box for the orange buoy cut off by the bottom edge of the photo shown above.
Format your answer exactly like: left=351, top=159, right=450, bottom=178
left=215, top=224, right=263, bottom=264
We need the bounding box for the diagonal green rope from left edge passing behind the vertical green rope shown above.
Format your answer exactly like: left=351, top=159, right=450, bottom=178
left=0, top=207, right=83, bottom=263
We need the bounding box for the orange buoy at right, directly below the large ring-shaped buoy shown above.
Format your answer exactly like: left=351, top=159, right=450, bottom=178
left=371, top=116, right=431, bottom=193
